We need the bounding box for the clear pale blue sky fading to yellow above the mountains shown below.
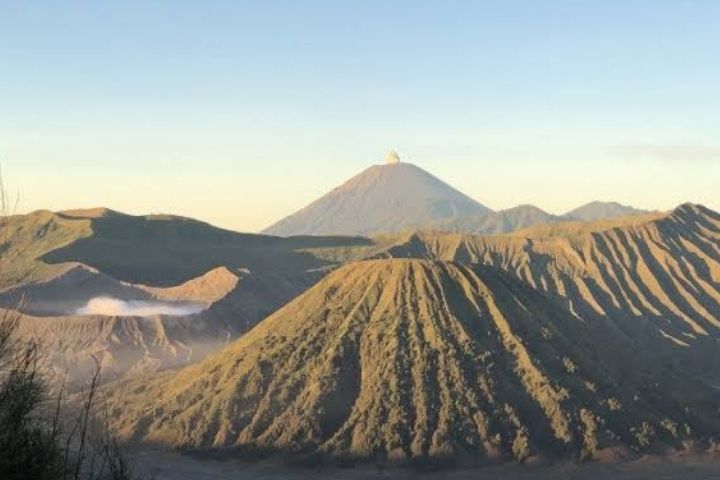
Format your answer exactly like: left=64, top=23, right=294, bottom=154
left=0, top=0, right=720, bottom=231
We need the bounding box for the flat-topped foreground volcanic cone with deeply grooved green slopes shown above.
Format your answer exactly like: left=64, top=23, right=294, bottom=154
left=108, top=260, right=720, bottom=461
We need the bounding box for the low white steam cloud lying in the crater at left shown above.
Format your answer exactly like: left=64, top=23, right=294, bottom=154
left=75, top=297, right=204, bottom=317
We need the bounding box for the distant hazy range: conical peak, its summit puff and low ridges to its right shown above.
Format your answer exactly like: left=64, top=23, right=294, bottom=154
left=261, top=157, right=647, bottom=237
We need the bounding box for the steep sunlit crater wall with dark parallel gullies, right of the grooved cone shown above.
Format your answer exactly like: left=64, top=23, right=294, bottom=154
left=379, top=204, right=720, bottom=345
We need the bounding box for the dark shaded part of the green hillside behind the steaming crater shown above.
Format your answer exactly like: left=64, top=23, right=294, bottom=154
left=42, top=210, right=368, bottom=286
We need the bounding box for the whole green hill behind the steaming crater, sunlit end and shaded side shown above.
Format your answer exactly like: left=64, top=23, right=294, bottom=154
left=0, top=209, right=371, bottom=288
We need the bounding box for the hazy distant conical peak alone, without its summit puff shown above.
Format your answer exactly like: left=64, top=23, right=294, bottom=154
left=263, top=161, right=490, bottom=236
